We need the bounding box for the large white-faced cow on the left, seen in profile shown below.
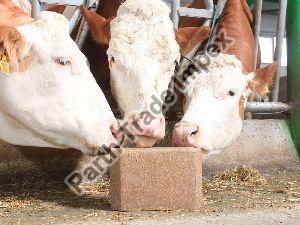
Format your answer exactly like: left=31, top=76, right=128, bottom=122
left=0, top=0, right=120, bottom=155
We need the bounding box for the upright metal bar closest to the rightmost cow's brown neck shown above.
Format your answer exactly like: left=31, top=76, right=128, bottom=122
left=252, top=0, right=263, bottom=71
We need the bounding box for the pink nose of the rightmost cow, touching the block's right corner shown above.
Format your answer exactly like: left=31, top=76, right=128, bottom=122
left=173, top=122, right=200, bottom=147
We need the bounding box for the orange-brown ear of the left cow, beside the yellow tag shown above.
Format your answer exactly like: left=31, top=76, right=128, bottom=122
left=0, top=25, right=27, bottom=73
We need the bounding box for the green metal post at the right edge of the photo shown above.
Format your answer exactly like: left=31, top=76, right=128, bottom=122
left=286, top=0, right=300, bottom=153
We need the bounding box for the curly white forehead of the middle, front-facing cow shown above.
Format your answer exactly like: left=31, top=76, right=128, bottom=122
left=108, top=0, right=179, bottom=71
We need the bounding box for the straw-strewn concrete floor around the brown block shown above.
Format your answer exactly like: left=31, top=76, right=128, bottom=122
left=0, top=165, right=300, bottom=225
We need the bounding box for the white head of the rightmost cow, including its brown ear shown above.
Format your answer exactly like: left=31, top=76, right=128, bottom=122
left=173, top=54, right=276, bottom=154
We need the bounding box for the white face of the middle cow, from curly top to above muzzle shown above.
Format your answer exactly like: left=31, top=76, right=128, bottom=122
left=107, top=0, right=180, bottom=119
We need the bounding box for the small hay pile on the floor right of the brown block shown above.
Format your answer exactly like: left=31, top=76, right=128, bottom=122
left=205, top=166, right=268, bottom=189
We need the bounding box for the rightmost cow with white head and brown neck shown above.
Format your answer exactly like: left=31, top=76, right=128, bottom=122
left=173, top=0, right=276, bottom=156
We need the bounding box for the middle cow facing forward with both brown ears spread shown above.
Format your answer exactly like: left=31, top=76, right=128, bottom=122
left=81, top=0, right=208, bottom=147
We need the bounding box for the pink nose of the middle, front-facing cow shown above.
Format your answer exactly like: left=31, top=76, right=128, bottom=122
left=131, top=115, right=166, bottom=139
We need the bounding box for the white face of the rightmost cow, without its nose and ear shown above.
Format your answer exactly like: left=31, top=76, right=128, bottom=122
left=182, top=54, right=252, bottom=154
